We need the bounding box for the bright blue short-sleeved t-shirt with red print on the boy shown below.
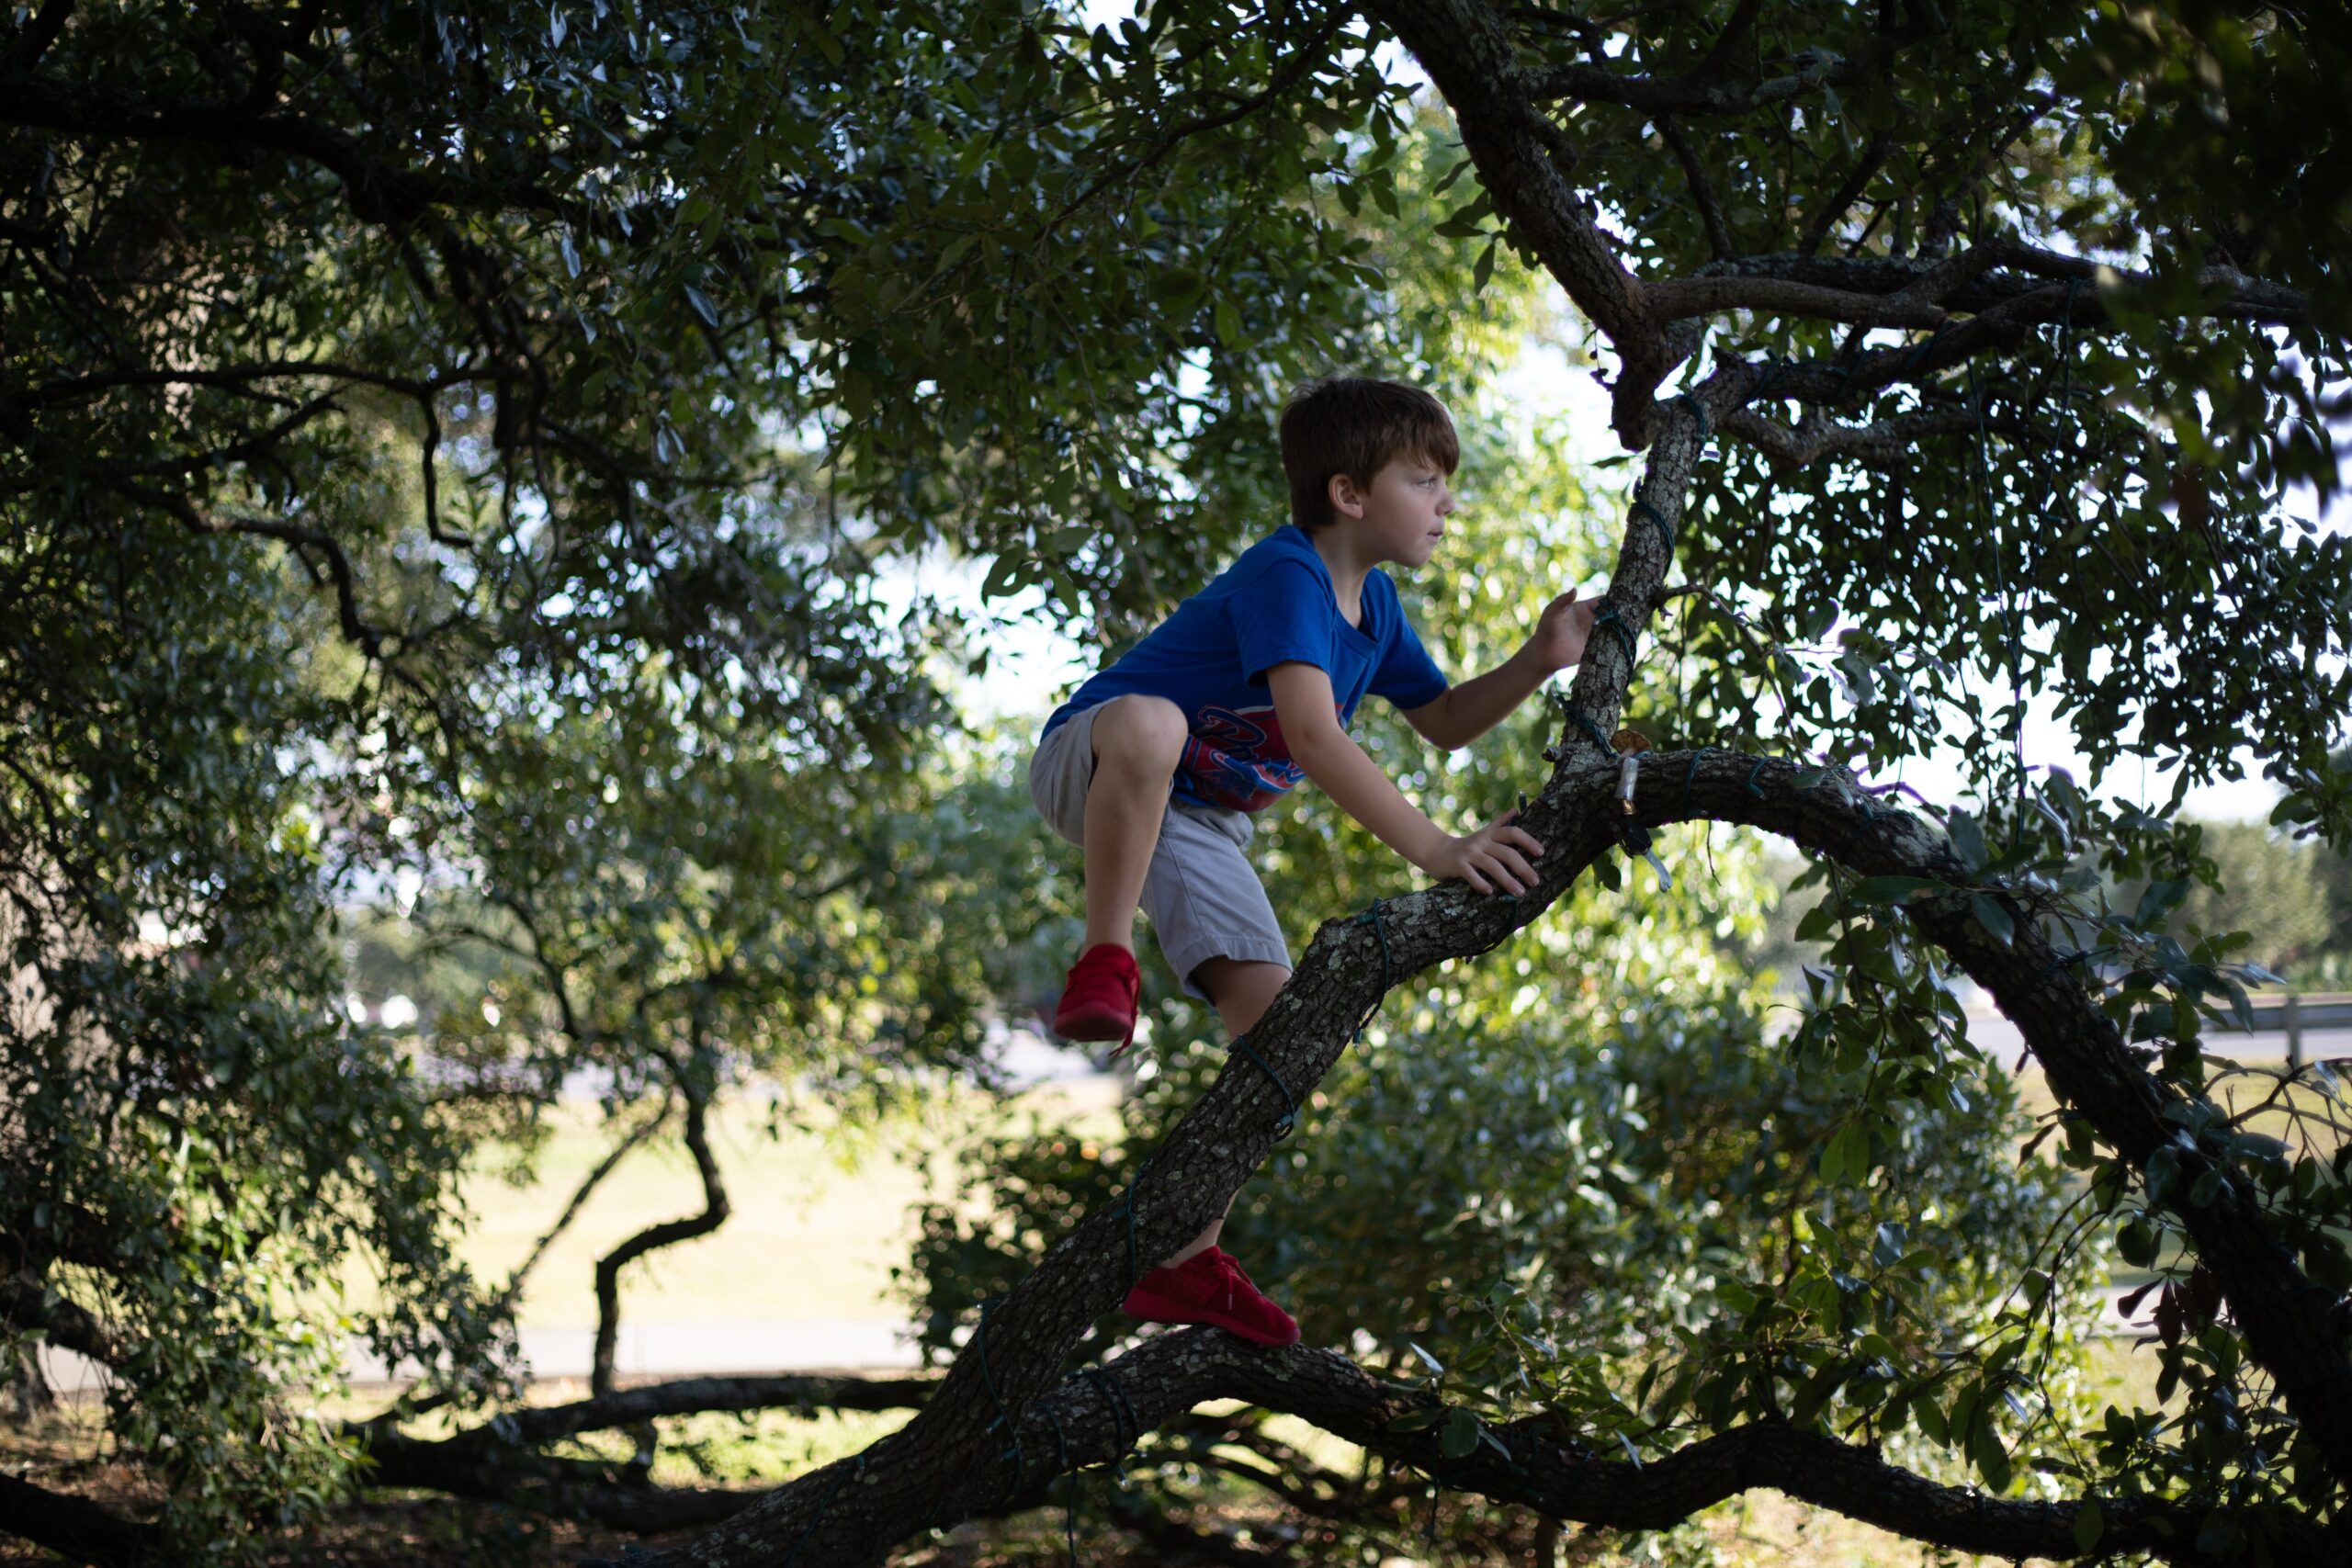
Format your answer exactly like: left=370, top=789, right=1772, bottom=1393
left=1045, top=525, right=1446, bottom=811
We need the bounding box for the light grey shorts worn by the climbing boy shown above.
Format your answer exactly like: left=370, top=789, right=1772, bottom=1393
left=1030, top=707, right=1291, bottom=1001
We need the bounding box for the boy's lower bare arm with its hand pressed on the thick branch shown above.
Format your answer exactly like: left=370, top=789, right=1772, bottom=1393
left=1265, top=663, right=1543, bottom=894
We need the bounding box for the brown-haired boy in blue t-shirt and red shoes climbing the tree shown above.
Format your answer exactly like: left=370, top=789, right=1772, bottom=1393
left=1030, top=376, right=1592, bottom=1345
